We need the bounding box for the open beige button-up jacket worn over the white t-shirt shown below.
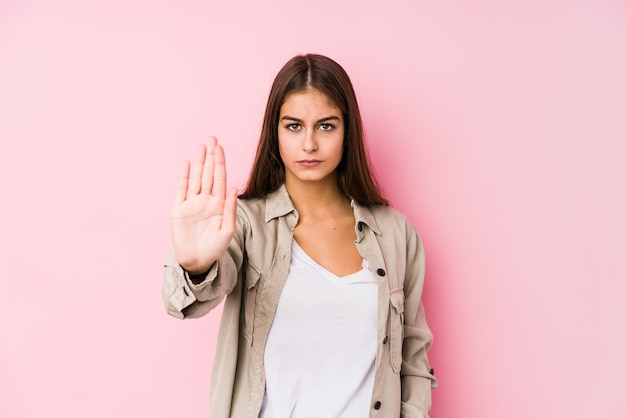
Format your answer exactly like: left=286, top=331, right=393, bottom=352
left=163, top=186, right=437, bottom=418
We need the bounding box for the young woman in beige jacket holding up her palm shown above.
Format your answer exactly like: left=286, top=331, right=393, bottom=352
left=164, top=55, right=436, bottom=418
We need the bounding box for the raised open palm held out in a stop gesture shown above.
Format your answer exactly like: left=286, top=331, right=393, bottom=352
left=171, top=137, right=237, bottom=274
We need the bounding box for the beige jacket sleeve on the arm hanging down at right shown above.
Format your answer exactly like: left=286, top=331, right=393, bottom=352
left=400, top=222, right=437, bottom=418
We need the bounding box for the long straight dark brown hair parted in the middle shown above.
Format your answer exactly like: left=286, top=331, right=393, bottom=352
left=239, top=54, right=388, bottom=206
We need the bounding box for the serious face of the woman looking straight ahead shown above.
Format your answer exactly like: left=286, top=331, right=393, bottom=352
left=278, top=89, right=344, bottom=188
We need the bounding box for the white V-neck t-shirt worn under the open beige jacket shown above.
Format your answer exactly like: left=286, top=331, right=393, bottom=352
left=259, top=240, right=378, bottom=418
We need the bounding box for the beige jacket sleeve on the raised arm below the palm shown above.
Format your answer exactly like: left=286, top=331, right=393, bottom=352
left=163, top=206, right=246, bottom=319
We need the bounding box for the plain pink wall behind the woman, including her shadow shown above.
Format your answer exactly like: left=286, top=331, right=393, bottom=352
left=0, top=0, right=626, bottom=418
